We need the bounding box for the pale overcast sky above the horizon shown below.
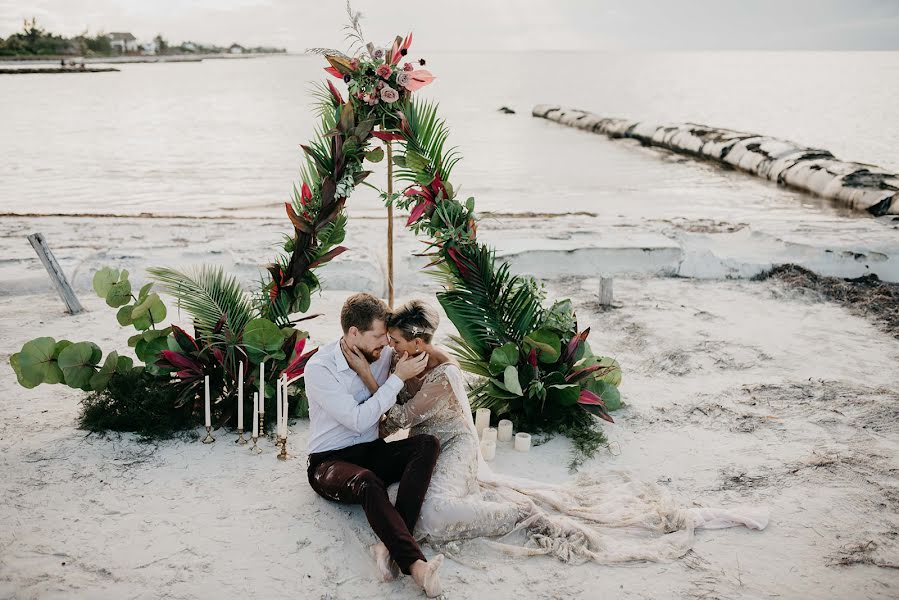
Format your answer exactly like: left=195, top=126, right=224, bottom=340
left=0, top=0, right=899, bottom=52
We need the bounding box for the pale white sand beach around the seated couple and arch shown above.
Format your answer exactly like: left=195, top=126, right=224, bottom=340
left=0, top=219, right=899, bottom=599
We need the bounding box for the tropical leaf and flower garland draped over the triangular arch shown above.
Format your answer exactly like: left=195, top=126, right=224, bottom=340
left=268, top=23, right=621, bottom=435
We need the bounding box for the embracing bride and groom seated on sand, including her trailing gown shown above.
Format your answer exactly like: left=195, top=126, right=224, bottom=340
left=305, top=294, right=768, bottom=596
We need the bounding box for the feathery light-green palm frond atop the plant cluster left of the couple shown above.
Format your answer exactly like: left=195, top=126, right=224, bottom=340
left=147, top=265, right=258, bottom=335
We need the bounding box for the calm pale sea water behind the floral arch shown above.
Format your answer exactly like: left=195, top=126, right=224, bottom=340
left=0, top=52, right=899, bottom=219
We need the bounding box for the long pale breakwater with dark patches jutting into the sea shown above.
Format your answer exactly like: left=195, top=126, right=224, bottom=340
left=531, top=104, right=899, bottom=216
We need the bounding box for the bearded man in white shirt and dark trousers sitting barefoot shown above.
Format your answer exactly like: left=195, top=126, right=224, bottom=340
left=305, top=294, right=443, bottom=596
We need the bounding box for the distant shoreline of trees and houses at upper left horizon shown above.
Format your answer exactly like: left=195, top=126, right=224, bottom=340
left=0, top=18, right=285, bottom=56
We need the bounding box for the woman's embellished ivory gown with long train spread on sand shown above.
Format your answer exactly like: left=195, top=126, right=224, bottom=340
left=385, top=363, right=768, bottom=563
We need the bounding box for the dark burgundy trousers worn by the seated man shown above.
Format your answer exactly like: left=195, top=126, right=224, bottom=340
left=308, top=435, right=440, bottom=575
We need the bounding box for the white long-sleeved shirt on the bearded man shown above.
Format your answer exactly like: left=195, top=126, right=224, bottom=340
left=304, top=339, right=403, bottom=454
